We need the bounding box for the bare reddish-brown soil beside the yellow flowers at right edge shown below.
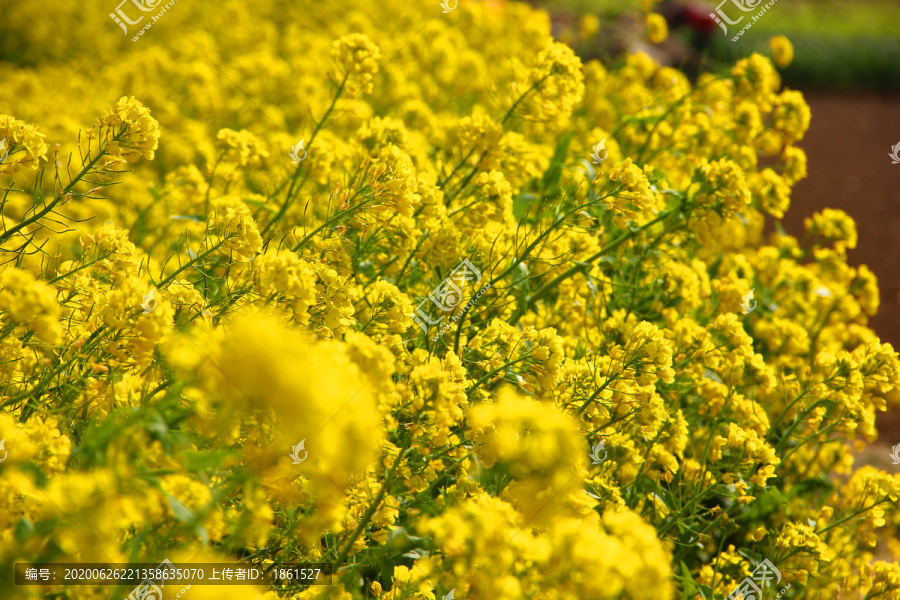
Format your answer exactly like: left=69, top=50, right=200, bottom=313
left=784, top=92, right=900, bottom=445
